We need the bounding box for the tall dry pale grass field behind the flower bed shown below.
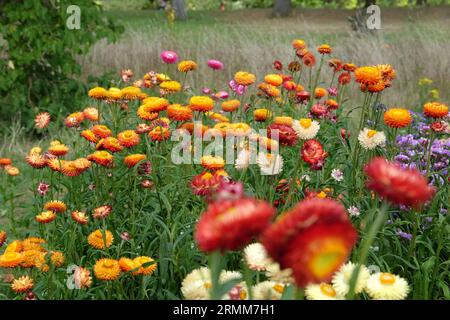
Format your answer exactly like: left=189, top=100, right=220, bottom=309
left=79, top=5, right=450, bottom=108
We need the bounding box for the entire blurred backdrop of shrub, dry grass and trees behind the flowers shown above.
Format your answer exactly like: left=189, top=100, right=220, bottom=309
left=0, top=0, right=450, bottom=132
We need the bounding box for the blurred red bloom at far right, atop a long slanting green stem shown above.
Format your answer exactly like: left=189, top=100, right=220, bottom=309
left=364, top=157, right=435, bottom=207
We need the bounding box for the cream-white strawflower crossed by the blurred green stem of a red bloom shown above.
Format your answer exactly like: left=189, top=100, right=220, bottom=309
left=331, top=262, right=370, bottom=296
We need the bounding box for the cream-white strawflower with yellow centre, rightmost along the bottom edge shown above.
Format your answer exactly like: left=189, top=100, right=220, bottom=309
left=365, top=272, right=409, bottom=300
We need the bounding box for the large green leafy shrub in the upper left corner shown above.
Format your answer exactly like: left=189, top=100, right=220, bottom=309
left=0, top=0, right=122, bottom=130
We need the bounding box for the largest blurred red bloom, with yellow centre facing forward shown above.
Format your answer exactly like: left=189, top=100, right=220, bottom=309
left=262, top=198, right=357, bottom=287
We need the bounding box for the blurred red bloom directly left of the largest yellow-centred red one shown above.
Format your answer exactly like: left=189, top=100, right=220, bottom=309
left=195, top=198, right=275, bottom=252
